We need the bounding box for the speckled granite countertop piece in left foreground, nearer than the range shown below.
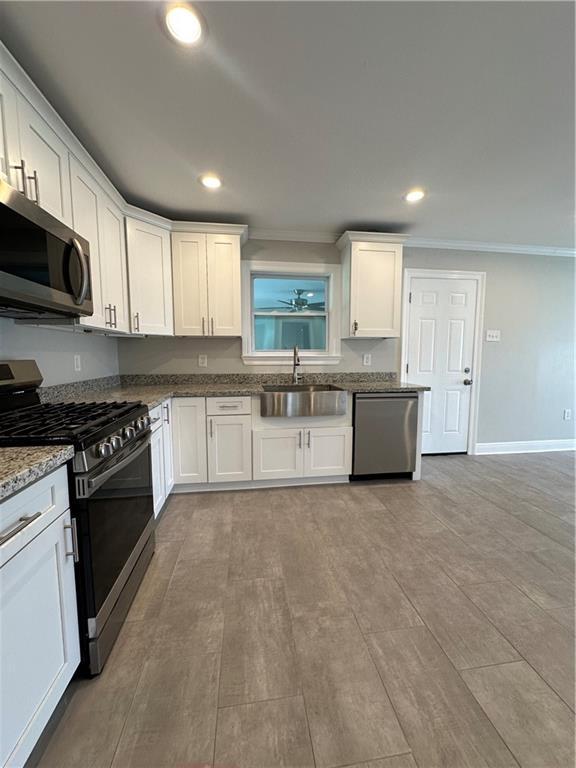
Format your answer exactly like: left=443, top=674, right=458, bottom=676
left=0, top=445, right=74, bottom=501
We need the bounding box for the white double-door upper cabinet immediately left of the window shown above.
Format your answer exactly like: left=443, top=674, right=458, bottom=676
left=172, top=227, right=244, bottom=336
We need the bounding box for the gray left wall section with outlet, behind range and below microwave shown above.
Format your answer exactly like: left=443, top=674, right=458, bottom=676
left=0, top=320, right=118, bottom=386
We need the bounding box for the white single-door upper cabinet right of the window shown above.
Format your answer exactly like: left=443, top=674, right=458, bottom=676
left=337, top=232, right=402, bottom=338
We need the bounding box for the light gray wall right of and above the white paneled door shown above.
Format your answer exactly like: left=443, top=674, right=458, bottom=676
left=404, top=248, right=575, bottom=443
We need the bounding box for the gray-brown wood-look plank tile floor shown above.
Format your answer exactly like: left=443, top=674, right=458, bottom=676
left=40, top=453, right=574, bottom=768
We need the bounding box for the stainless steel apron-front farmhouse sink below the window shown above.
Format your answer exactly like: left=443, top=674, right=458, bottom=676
left=260, top=384, right=348, bottom=418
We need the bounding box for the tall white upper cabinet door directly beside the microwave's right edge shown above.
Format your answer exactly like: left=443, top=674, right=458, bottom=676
left=70, top=155, right=107, bottom=328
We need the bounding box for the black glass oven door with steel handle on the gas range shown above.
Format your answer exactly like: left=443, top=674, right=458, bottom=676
left=72, top=434, right=154, bottom=638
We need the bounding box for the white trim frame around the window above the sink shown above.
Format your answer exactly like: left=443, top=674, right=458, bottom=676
left=242, top=261, right=342, bottom=366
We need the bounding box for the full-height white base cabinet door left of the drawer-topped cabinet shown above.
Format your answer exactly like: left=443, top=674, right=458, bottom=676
left=172, top=397, right=208, bottom=485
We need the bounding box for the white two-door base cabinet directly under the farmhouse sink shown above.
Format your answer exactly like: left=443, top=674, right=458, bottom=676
left=252, top=427, right=352, bottom=480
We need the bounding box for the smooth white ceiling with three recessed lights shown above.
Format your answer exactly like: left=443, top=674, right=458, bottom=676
left=0, top=2, right=574, bottom=247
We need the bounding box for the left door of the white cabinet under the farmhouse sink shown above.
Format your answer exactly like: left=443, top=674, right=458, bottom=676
left=252, top=429, right=304, bottom=480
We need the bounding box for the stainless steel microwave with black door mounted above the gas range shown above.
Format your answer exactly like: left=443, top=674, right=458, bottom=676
left=0, top=179, right=93, bottom=320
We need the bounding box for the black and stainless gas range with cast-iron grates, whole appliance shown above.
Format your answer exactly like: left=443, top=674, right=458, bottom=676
left=0, top=360, right=154, bottom=675
